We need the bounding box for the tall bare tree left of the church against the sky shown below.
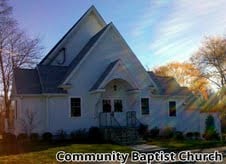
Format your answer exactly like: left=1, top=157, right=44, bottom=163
left=0, top=0, right=41, bottom=125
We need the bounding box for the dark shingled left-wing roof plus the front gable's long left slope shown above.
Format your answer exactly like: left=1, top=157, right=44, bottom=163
left=14, top=25, right=109, bottom=94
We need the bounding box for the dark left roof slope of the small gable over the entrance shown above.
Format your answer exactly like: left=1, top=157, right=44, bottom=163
left=90, top=60, right=119, bottom=91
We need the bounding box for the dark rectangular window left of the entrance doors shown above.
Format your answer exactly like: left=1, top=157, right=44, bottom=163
left=71, top=98, right=81, bottom=117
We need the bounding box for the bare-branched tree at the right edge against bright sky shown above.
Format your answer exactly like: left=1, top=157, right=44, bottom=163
left=191, top=37, right=226, bottom=88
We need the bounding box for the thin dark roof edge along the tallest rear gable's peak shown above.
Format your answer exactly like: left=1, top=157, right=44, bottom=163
left=39, top=5, right=106, bottom=65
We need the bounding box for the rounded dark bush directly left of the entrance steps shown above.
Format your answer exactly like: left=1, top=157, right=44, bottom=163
left=88, top=127, right=104, bottom=143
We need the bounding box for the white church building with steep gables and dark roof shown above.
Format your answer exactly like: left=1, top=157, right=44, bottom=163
left=12, top=6, right=220, bottom=138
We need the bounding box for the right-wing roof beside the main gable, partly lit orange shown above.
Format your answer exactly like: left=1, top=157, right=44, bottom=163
left=148, top=72, right=192, bottom=96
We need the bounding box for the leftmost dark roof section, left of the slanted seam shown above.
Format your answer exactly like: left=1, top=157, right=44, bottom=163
left=14, top=69, right=42, bottom=94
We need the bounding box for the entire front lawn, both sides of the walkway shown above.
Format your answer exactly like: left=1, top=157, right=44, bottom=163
left=0, top=139, right=226, bottom=164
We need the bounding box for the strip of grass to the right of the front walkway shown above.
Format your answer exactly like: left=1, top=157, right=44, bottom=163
left=147, top=139, right=226, bottom=151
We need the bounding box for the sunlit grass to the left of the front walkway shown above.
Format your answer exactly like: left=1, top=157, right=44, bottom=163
left=0, top=143, right=131, bottom=164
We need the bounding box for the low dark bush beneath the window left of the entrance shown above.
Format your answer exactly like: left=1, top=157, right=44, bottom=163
left=70, top=129, right=88, bottom=143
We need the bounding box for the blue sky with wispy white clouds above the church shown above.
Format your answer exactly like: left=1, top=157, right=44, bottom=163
left=10, top=0, right=226, bottom=69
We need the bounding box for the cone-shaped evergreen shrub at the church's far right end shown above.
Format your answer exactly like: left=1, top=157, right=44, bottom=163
left=203, top=115, right=220, bottom=140
